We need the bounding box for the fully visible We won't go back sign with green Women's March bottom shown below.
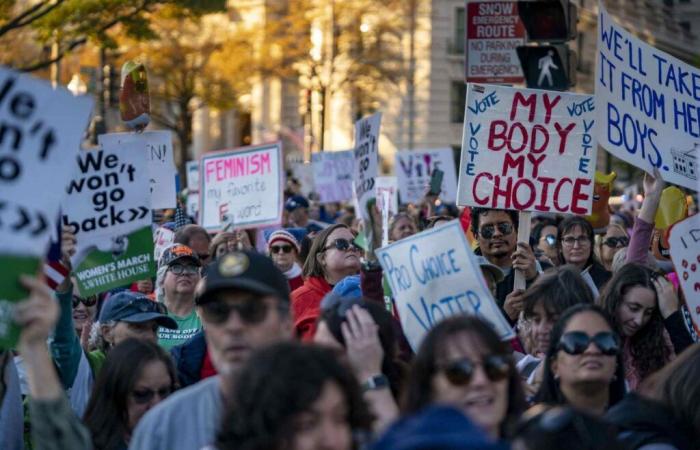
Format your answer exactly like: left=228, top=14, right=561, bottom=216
left=62, top=146, right=155, bottom=295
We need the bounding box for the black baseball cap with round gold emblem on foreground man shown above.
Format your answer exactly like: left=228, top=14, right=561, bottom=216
left=195, top=250, right=289, bottom=305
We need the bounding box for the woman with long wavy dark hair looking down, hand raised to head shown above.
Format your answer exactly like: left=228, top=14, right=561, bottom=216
left=600, top=263, right=692, bottom=390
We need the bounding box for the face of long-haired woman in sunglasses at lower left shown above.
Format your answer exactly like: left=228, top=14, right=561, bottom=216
left=127, top=361, right=174, bottom=432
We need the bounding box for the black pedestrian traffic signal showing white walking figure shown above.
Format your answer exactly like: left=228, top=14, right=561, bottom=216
left=517, top=0, right=578, bottom=91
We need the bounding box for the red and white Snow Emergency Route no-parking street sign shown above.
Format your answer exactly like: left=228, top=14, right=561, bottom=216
left=465, top=1, right=526, bottom=83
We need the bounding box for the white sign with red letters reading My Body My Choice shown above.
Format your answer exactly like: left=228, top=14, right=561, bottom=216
left=457, top=84, right=596, bottom=215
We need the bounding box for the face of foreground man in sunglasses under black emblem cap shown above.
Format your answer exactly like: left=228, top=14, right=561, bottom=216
left=199, top=290, right=291, bottom=375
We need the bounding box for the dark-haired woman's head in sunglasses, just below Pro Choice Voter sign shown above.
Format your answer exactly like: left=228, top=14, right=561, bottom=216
left=403, top=316, right=525, bottom=440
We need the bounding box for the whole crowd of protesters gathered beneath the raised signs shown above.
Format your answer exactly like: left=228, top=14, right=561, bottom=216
left=0, top=169, right=700, bottom=450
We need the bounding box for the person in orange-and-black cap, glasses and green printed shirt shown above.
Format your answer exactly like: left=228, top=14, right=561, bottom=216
left=158, top=244, right=202, bottom=349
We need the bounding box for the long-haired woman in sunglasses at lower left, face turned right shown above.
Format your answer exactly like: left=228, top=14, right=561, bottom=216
left=83, top=339, right=176, bottom=450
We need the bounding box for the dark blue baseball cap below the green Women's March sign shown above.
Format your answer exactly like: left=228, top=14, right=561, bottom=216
left=100, top=291, right=177, bottom=330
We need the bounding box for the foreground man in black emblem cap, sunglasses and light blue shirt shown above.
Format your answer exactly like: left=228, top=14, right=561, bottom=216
left=130, top=251, right=292, bottom=450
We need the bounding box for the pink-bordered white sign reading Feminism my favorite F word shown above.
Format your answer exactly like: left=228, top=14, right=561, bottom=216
left=199, top=142, right=283, bottom=231
